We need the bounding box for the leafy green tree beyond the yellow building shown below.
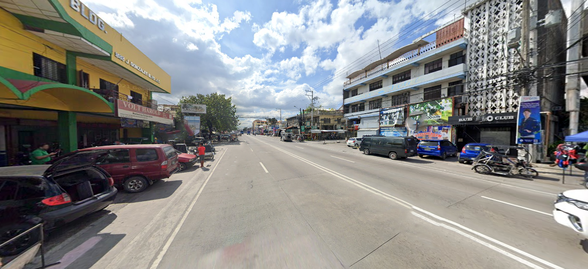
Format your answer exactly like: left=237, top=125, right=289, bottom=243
left=180, top=93, right=239, bottom=133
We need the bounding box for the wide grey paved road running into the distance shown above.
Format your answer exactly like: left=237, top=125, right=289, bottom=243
left=28, top=136, right=588, bottom=268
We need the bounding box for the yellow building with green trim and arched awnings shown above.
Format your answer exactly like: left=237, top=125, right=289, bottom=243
left=0, top=0, right=173, bottom=166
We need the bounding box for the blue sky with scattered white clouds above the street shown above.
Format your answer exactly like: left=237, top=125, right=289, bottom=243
left=83, top=0, right=571, bottom=126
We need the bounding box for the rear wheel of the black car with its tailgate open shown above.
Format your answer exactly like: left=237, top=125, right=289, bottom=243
left=0, top=223, right=40, bottom=257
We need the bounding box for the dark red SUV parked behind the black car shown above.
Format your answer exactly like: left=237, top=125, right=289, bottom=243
left=54, top=144, right=179, bottom=192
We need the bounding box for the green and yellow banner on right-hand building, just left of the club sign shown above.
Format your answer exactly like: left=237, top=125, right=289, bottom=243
left=409, top=98, right=453, bottom=125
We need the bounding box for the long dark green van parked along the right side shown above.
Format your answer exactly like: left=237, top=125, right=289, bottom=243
left=359, top=136, right=418, bottom=160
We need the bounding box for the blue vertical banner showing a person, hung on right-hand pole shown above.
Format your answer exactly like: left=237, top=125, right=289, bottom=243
left=516, top=96, right=541, bottom=144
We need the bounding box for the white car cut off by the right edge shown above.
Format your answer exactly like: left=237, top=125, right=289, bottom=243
left=553, top=189, right=588, bottom=239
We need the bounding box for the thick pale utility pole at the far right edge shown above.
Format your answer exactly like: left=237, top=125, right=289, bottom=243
left=566, top=0, right=584, bottom=135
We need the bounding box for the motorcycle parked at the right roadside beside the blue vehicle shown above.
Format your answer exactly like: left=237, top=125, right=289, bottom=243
left=472, top=148, right=539, bottom=178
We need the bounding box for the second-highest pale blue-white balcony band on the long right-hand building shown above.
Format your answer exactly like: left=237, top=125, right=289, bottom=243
left=343, top=64, right=467, bottom=105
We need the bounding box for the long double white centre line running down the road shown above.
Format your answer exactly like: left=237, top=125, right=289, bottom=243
left=254, top=137, right=563, bottom=269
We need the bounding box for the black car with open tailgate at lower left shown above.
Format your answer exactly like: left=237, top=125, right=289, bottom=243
left=0, top=163, right=117, bottom=254
